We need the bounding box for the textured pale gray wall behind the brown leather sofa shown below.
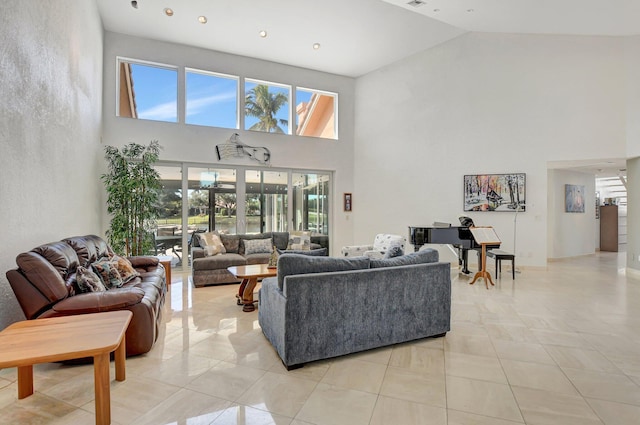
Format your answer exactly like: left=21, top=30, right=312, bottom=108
left=0, top=0, right=103, bottom=329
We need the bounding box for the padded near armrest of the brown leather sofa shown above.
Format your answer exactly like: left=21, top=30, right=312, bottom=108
left=53, top=287, right=144, bottom=315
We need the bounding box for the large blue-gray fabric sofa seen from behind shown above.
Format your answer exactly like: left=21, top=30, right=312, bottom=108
left=258, top=249, right=451, bottom=369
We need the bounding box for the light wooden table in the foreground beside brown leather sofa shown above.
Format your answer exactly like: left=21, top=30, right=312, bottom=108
left=0, top=310, right=133, bottom=425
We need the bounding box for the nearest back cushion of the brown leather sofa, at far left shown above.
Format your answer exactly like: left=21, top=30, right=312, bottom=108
left=16, top=241, right=79, bottom=303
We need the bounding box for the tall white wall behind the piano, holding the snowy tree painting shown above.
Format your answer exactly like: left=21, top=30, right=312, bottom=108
left=354, top=33, right=626, bottom=266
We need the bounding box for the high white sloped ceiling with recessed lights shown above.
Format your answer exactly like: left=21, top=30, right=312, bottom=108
left=96, top=0, right=640, bottom=77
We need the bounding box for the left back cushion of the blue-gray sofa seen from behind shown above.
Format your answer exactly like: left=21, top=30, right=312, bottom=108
left=278, top=254, right=369, bottom=290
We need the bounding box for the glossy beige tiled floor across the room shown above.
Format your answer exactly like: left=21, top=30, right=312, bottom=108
left=0, top=253, right=640, bottom=425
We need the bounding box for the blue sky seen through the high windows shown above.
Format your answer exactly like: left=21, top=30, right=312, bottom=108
left=131, top=63, right=311, bottom=132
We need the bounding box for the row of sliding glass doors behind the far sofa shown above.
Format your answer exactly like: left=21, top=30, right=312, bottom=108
left=154, top=163, right=331, bottom=266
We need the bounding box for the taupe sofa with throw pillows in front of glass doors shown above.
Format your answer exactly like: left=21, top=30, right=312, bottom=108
left=191, top=232, right=329, bottom=287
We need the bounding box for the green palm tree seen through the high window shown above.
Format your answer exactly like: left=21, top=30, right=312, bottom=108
left=244, top=84, right=289, bottom=133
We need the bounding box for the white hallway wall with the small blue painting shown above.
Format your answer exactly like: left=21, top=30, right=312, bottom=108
left=547, top=170, right=599, bottom=258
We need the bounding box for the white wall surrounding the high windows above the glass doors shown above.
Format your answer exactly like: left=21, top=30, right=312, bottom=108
left=103, top=32, right=357, bottom=252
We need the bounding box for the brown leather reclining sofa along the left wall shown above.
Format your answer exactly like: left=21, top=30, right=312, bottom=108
left=7, top=235, right=167, bottom=356
